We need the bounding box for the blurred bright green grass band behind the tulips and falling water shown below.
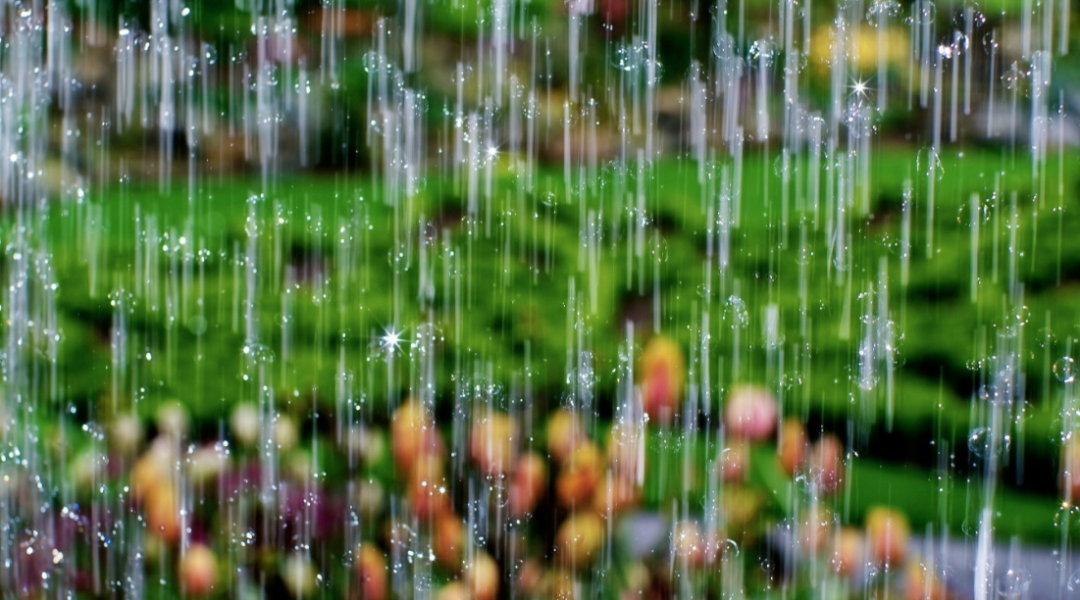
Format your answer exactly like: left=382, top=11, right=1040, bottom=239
left=16, top=145, right=1080, bottom=548
